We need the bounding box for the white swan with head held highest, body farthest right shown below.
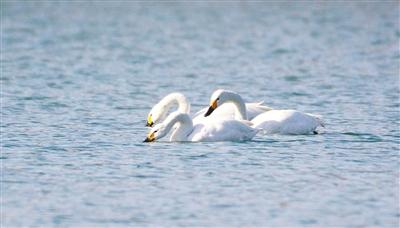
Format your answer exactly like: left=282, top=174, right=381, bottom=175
left=204, top=89, right=324, bottom=135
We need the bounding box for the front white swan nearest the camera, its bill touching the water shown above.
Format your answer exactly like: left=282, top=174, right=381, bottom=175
left=144, top=111, right=259, bottom=142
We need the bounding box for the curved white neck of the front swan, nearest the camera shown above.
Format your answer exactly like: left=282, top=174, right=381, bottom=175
left=166, top=112, right=193, bottom=142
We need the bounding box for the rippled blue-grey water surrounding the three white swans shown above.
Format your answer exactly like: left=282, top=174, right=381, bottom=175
left=1, top=1, right=400, bottom=227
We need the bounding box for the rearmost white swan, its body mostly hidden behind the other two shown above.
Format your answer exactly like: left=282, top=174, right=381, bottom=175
left=146, top=92, right=271, bottom=127
